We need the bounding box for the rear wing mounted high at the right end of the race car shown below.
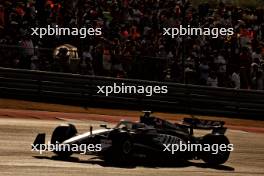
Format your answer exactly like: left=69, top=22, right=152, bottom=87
left=183, top=118, right=226, bottom=134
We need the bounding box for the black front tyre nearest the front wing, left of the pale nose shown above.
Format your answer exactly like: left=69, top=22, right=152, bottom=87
left=51, top=124, right=77, bottom=157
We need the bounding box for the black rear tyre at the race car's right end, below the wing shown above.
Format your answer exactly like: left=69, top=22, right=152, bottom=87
left=201, top=134, right=230, bottom=165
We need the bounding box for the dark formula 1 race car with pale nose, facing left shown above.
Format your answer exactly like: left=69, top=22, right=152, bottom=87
left=32, top=111, right=233, bottom=165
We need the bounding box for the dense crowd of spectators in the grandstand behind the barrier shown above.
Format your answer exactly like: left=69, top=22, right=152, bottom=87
left=0, top=0, right=264, bottom=90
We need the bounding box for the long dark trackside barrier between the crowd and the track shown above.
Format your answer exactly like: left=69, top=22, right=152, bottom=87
left=0, top=68, right=264, bottom=120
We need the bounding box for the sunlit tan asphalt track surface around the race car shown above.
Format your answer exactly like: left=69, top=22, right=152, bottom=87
left=0, top=109, right=264, bottom=176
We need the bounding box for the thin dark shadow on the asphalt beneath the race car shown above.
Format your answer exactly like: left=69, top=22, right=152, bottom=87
left=33, top=156, right=235, bottom=171
